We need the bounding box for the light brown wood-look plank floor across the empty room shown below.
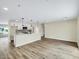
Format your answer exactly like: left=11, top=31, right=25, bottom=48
left=0, top=37, right=79, bottom=59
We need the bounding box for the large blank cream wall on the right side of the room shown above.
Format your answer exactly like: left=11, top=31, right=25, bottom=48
left=45, top=19, right=77, bottom=42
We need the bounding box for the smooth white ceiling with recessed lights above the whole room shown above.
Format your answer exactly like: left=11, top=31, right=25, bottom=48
left=0, top=0, right=78, bottom=23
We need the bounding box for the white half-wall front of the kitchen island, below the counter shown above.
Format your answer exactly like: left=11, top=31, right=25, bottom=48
left=14, top=33, right=41, bottom=47
